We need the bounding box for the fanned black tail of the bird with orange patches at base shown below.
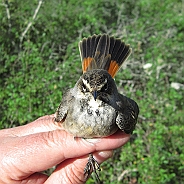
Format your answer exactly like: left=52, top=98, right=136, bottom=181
left=79, top=34, right=131, bottom=77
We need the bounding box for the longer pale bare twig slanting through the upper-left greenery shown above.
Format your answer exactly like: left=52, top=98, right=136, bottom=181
left=20, top=0, right=43, bottom=48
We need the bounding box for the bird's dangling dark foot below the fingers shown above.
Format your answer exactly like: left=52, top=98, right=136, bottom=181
left=84, top=153, right=101, bottom=184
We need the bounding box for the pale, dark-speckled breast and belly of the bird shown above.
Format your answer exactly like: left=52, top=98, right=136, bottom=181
left=63, top=92, right=118, bottom=138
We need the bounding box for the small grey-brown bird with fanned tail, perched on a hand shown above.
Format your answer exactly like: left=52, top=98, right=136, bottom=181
left=55, top=34, right=139, bottom=181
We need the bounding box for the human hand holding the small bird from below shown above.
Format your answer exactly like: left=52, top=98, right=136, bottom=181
left=0, top=115, right=130, bottom=184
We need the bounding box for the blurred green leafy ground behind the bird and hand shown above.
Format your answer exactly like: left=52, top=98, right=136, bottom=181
left=0, top=0, right=184, bottom=184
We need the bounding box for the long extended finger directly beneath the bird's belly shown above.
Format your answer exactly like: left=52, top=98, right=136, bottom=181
left=0, top=130, right=129, bottom=180
